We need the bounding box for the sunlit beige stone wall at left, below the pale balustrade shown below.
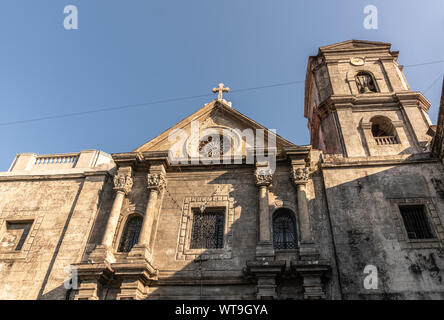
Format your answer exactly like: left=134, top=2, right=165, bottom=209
left=0, top=174, right=109, bottom=299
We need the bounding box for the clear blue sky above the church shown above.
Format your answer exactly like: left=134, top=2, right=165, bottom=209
left=0, top=0, right=444, bottom=171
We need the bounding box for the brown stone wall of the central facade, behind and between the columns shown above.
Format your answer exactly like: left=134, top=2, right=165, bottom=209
left=84, top=163, right=338, bottom=299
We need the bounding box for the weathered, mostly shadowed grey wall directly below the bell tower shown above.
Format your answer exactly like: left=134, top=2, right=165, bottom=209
left=323, top=157, right=444, bottom=299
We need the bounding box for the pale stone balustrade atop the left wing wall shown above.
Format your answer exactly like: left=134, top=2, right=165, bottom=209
left=8, top=150, right=115, bottom=174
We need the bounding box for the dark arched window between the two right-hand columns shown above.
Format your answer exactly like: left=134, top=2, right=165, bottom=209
left=273, top=209, right=297, bottom=250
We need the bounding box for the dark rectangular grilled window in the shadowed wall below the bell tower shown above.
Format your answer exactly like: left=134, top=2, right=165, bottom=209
left=399, top=204, right=435, bottom=239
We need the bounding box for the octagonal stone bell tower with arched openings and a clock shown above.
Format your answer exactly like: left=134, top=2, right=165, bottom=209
left=304, top=40, right=431, bottom=157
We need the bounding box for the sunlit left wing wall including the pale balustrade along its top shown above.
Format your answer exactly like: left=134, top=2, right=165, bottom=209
left=0, top=150, right=114, bottom=299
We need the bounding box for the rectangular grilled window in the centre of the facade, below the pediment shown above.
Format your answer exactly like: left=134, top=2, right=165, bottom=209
left=190, top=209, right=225, bottom=249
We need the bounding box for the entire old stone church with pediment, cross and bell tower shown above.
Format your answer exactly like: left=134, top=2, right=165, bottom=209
left=0, top=40, right=444, bottom=300
